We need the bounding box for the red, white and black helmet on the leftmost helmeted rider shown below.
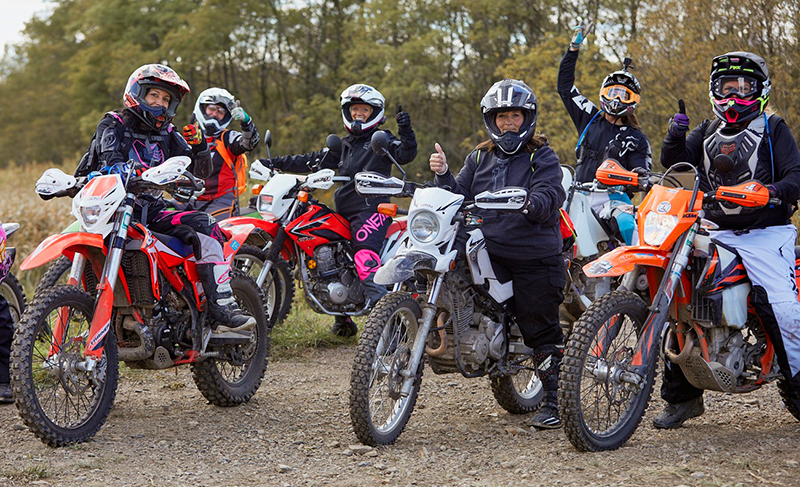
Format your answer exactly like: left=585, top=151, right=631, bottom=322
left=122, top=64, right=189, bottom=130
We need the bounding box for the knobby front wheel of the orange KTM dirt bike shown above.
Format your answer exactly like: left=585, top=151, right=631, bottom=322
left=559, top=290, right=656, bottom=451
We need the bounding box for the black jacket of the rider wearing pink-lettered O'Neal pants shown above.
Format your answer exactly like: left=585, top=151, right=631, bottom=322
left=270, top=128, right=417, bottom=220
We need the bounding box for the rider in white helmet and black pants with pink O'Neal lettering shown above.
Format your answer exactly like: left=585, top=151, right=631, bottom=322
left=261, top=84, right=417, bottom=337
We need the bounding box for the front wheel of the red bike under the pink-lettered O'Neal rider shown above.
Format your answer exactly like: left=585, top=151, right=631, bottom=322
left=233, top=244, right=295, bottom=324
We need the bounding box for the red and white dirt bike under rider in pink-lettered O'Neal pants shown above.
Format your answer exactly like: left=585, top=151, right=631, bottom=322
left=220, top=132, right=406, bottom=321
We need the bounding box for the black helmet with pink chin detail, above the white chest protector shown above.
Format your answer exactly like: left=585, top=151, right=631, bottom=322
left=708, top=51, right=770, bottom=123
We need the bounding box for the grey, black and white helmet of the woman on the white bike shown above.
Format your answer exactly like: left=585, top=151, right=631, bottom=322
left=481, top=78, right=539, bottom=154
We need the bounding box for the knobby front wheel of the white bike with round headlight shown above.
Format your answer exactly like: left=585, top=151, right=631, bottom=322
left=350, top=292, right=422, bottom=445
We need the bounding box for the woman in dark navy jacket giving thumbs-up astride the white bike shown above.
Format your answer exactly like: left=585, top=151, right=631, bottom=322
left=429, top=79, right=566, bottom=428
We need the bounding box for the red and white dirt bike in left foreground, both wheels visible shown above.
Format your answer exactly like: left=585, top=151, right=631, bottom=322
left=11, top=157, right=271, bottom=446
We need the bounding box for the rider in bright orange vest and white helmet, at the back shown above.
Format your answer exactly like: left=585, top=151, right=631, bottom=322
left=181, top=88, right=259, bottom=220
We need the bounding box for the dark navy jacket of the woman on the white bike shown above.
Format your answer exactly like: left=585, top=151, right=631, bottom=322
left=436, top=146, right=566, bottom=259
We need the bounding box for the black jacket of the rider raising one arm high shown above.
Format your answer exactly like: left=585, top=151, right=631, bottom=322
left=558, top=50, right=653, bottom=183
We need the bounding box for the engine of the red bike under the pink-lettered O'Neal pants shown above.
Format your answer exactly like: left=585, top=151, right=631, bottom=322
left=308, top=243, right=364, bottom=311
